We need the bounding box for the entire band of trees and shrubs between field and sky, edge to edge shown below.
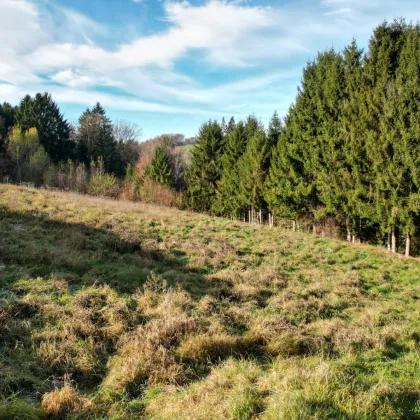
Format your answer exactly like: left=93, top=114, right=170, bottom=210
left=0, top=19, right=420, bottom=255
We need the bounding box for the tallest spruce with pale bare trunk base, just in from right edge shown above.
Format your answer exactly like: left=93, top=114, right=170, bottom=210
left=364, top=21, right=407, bottom=252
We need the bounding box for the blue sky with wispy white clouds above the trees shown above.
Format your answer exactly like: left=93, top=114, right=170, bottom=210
left=0, top=0, right=420, bottom=140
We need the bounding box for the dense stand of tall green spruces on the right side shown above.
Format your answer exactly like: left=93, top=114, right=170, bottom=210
left=187, top=19, right=420, bottom=255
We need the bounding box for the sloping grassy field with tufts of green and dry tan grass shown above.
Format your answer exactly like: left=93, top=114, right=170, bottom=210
left=0, top=185, right=420, bottom=420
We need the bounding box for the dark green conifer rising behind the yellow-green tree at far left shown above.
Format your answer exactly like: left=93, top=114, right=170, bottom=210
left=14, top=93, right=75, bottom=163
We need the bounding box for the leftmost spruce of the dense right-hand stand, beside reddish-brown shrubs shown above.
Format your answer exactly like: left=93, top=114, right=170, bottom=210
left=186, top=121, right=224, bottom=211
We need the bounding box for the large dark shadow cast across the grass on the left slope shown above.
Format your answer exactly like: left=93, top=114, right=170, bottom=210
left=0, top=208, right=231, bottom=297
